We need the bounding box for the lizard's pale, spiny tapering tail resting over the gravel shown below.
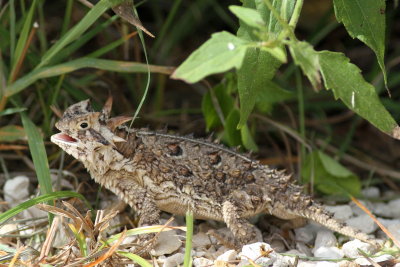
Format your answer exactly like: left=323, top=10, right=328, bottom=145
left=299, top=205, right=381, bottom=247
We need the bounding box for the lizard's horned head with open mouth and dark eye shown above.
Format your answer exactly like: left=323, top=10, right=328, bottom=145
left=51, top=97, right=131, bottom=161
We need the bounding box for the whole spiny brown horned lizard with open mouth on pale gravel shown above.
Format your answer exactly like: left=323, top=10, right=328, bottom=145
left=51, top=98, right=377, bottom=249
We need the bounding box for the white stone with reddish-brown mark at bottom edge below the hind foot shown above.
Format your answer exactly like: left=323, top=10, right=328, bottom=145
left=240, top=242, right=277, bottom=266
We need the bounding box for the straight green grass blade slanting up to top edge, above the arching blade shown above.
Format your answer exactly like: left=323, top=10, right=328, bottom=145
left=35, top=0, right=123, bottom=69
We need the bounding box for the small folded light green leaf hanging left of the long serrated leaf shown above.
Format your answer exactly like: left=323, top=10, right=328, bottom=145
left=289, top=41, right=321, bottom=89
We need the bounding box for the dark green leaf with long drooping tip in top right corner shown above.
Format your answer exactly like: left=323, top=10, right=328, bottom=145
left=333, top=0, right=387, bottom=88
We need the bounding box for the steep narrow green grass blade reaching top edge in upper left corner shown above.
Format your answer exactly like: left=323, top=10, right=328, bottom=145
left=8, top=0, right=37, bottom=81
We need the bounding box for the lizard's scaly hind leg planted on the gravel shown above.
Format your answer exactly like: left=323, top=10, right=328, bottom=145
left=222, top=200, right=259, bottom=248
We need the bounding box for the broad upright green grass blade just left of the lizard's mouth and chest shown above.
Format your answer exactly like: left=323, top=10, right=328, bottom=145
left=21, top=113, right=53, bottom=197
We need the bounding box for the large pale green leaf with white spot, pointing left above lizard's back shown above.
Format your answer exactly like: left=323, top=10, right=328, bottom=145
left=171, top=32, right=249, bottom=83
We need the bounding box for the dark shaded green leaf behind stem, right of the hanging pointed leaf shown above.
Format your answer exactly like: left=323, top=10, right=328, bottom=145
left=256, top=81, right=295, bottom=113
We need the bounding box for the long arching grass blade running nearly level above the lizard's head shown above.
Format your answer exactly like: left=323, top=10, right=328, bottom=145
left=4, top=58, right=173, bottom=97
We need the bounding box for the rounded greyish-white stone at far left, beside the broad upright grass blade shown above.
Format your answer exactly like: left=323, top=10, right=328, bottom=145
left=3, top=175, right=29, bottom=207
